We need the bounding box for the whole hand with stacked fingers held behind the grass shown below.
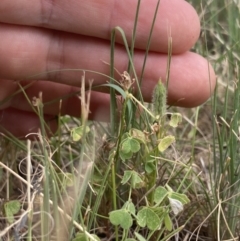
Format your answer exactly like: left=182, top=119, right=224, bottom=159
left=0, top=0, right=216, bottom=137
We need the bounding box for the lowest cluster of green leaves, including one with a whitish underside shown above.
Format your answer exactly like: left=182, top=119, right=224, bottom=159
left=109, top=183, right=190, bottom=231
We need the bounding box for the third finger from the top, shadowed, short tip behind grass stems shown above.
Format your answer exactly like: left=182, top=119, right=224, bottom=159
left=0, top=80, right=110, bottom=121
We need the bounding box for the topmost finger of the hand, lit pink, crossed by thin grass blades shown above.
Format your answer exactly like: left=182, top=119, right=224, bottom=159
left=0, top=0, right=200, bottom=53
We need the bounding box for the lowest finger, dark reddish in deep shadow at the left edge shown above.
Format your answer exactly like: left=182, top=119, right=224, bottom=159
left=0, top=108, right=57, bottom=139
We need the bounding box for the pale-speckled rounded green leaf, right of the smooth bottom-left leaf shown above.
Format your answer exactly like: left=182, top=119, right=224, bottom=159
left=137, top=207, right=161, bottom=231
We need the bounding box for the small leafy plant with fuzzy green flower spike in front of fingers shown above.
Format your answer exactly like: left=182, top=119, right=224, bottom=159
left=105, top=71, right=189, bottom=241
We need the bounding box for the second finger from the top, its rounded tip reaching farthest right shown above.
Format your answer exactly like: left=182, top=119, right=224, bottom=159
left=0, top=25, right=216, bottom=107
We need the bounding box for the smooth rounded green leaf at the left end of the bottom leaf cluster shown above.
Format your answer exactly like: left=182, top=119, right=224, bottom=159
left=109, top=209, right=133, bottom=229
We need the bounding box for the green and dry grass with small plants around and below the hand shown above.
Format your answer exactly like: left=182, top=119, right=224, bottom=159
left=0, top=0, right=240, bottom=241
